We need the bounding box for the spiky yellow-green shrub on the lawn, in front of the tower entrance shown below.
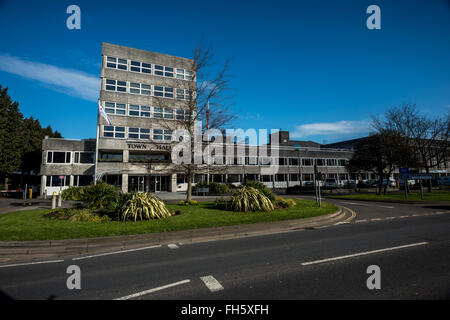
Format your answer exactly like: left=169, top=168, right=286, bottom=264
left=121, top=193, right=172, bottom=221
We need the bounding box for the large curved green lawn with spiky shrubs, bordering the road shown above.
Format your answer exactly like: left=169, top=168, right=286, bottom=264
left=0, top=199, right=337, bottom=240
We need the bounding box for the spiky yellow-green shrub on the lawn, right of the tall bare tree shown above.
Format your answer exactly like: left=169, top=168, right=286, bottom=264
left=229, top=186, right=274, bottom=212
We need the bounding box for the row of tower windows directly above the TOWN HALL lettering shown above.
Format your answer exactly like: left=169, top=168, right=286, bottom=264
left=103, top=126, right=172, bottom=141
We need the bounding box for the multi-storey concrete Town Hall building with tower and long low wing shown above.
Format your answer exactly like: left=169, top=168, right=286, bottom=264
left=41, top=43, right=394, bottom=194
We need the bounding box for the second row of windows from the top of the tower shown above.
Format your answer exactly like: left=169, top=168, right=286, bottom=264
left=105, top=79, right=189, bottom=100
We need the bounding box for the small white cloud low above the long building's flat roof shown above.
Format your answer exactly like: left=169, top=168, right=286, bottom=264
left=291, top=120, right=370, bottom=138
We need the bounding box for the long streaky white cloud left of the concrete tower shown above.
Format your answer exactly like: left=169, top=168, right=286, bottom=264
left=0, top=54, right=100, bottom=101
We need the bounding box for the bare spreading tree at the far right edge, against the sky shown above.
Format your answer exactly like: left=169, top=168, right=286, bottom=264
left=374, top=103, right=450, bottom=192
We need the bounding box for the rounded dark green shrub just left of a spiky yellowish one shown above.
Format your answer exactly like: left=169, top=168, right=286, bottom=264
left=81, top=181, right=119, bottom=210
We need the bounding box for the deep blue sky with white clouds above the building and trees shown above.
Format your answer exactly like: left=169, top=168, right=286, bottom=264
left=0, top=0, right=450, bottom=142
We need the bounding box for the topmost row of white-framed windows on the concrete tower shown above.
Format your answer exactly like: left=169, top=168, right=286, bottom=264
left=106, top=57, right=194, bottom=80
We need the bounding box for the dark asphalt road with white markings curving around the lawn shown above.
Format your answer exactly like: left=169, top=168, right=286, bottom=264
left=0, top=200, right=450, bottom=300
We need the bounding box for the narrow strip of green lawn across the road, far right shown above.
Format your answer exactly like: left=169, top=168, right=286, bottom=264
left=329, top=190, right=450, bottom=201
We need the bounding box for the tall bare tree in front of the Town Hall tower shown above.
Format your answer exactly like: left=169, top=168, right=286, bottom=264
left=152, top=43, right=236, bottom=201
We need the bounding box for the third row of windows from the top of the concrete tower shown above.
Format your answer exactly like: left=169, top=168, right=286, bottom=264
left=105, top=102, right=190, bottom=120
